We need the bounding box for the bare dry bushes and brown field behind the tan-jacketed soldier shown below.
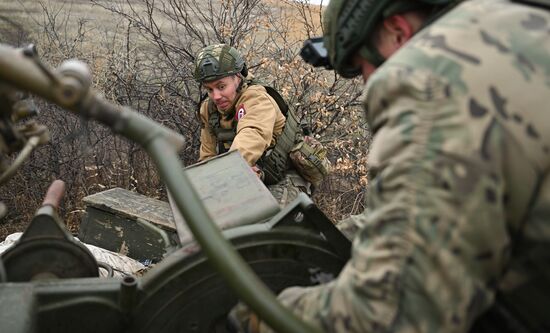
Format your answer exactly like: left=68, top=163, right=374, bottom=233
left=0, top=0, right=369, bottom=239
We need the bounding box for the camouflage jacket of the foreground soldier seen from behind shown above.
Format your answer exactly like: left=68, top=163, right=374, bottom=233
left=262, top=0, right=550, bottom=333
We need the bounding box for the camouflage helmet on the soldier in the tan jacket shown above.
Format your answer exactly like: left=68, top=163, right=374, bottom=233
left=194, top=44, right=248, bottom=83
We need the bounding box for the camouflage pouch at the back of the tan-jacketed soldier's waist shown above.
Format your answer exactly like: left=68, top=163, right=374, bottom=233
left=289, top=135, right=330, bottom=186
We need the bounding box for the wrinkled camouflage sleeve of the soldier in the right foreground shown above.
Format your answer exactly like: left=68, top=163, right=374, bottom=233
left=263, top=66, right=509, bottom=333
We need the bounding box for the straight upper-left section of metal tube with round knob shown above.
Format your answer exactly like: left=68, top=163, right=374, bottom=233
left=0, top=44, right=184, bottom=150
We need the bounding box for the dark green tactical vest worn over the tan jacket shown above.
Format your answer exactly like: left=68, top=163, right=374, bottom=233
left=208, top=81, right=302, bottom=185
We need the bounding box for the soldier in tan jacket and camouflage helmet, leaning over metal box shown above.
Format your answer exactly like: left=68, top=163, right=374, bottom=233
left=194, top=44, right=309, bottom=207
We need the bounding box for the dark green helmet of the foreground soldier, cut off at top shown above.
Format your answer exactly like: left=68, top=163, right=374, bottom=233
left=323, top=0, right=457, bottom=78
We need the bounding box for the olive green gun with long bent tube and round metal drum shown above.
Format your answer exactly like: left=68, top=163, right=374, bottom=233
left=0, top=45, right=350, bottom=332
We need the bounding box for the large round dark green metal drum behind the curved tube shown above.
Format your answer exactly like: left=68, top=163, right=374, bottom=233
left=132, top=227, right=348, bottom=333
